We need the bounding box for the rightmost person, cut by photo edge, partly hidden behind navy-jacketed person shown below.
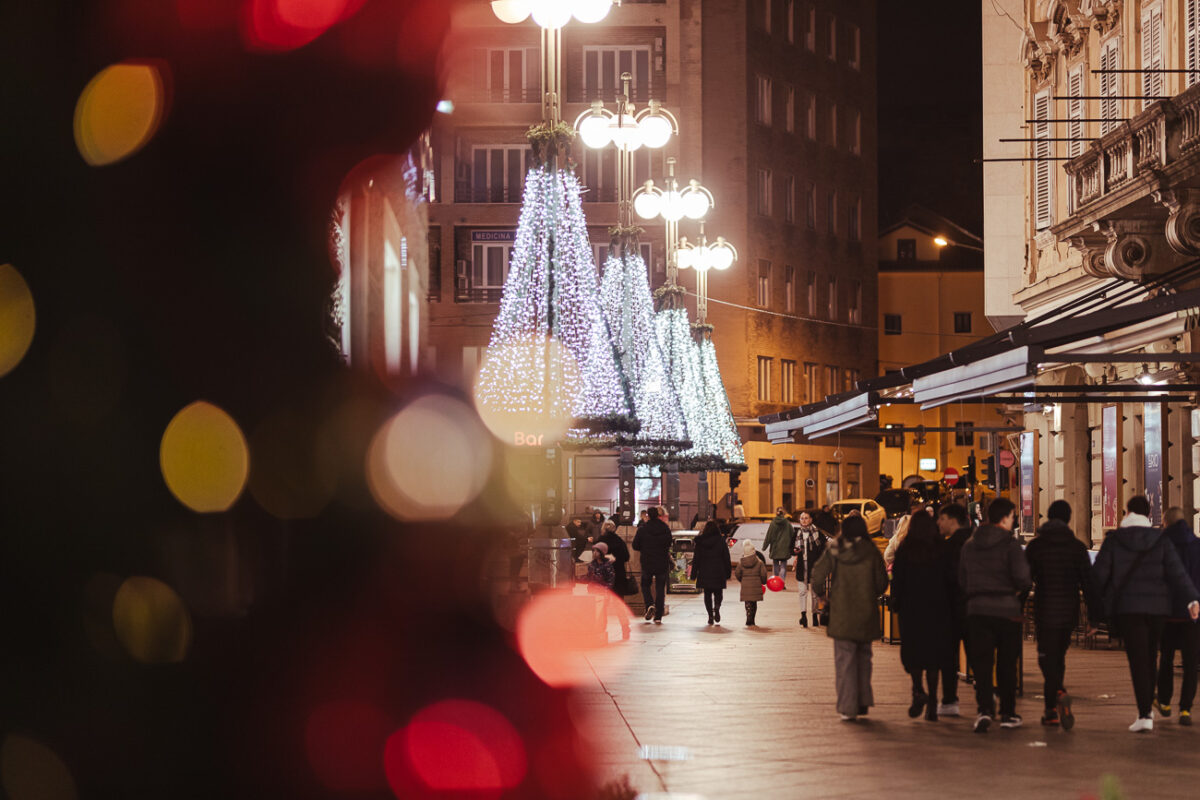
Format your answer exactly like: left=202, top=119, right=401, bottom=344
left=1154, top=506, right=1200, bottom=726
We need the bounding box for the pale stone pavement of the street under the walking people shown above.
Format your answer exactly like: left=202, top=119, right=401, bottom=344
left=575, top=576, right=1200, bottom=800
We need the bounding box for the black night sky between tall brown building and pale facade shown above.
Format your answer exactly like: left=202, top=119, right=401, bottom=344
left=878, top=0, right=983, bottom=234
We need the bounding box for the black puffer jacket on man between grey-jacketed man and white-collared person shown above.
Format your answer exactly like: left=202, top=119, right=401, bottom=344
left=1025, top=519, right=1104, bottom=628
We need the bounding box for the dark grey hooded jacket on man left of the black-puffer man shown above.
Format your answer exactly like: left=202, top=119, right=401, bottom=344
left=959, top=525, right=1032, bottom=619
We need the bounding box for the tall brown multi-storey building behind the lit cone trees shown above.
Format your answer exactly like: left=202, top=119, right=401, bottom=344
left=428, top=0, right=877, bottom=513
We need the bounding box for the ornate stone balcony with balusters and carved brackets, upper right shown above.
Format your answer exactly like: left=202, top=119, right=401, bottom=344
left=1056, top=84, right=1200, bottom=281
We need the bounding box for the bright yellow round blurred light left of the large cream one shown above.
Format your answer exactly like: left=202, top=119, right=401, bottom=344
left=158, top=401, right=250, bottom=513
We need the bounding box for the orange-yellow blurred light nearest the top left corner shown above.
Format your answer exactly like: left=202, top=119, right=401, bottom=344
left=74, top=62, right=168, bottom=167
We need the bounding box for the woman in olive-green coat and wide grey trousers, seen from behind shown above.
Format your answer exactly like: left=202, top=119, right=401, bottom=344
left=812, top=517, right=888, bottom=722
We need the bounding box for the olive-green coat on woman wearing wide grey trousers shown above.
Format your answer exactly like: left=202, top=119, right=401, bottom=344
left=812, top=537, right=888, bottom=643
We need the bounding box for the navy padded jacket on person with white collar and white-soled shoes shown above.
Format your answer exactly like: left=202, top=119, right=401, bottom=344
left=1093, top=525, right=1200, bottom=621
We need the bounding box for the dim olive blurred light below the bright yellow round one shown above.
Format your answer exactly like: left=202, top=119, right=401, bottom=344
left=113, top=576, right=192, bottom=664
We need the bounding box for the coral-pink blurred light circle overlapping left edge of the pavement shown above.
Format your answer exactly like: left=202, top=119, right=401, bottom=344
left=517, top=589, right=629, bottom=687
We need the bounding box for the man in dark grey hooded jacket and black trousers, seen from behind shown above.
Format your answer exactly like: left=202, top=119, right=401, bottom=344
left=959, top=498, right=1031, bottom=733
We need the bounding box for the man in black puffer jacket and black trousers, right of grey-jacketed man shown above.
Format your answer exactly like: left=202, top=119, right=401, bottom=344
left=1025, top=500, right=1103, bottom=730
